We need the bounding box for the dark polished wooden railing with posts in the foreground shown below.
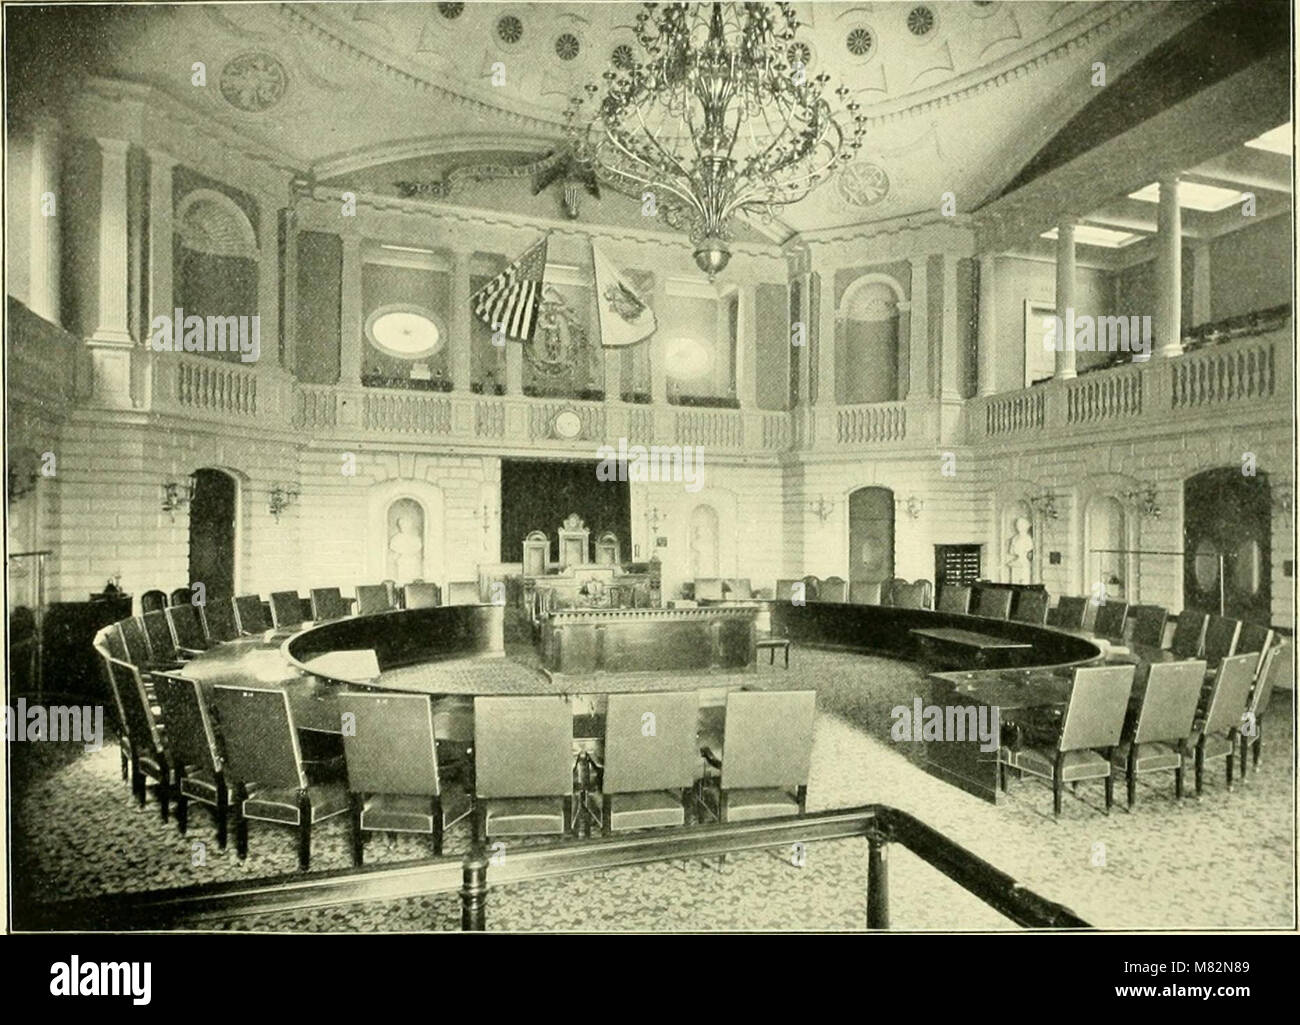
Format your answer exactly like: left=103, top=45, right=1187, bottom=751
left=14, top=804, right=1091, bottom=931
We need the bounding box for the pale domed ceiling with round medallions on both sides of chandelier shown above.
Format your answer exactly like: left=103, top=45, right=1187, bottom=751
left=35, top=0, right=1222, bottom=239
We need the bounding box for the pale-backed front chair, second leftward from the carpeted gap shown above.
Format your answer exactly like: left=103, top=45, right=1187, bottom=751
left=601, top=691, right=699, bottom=835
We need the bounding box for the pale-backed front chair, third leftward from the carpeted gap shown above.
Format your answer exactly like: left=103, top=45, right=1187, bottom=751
left=475, top=697, right=573, bottom=839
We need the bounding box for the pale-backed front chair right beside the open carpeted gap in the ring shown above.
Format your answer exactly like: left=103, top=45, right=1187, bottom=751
left=701, top=691, right=816, bottom=822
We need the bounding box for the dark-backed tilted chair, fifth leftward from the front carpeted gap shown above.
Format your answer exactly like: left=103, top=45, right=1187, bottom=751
left=212, top=684, right=356, bottom=872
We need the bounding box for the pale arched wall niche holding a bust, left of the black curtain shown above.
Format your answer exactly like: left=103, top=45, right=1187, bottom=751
left=365, top=479, right=447, bottom=589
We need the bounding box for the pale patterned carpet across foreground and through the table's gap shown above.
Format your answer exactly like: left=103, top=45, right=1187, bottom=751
left=10, top=649, right=1295, bottom=931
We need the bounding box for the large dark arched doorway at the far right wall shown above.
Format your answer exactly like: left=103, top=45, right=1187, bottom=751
left=1183, top=467, right=1273, bottom=623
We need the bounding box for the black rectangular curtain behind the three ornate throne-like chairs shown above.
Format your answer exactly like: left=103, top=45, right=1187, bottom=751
left=501, top=459, right=633, bottom=562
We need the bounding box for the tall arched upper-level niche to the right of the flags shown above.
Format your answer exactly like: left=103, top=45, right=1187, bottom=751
left=835, top=273, right=907, bottom=405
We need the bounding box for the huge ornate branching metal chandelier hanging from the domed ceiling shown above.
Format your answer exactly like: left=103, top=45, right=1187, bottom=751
left=566, top=3, right=866, bottom=280
